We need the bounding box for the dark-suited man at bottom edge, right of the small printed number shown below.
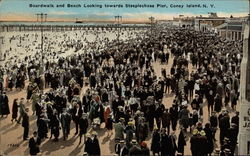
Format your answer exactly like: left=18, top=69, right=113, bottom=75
left=29, top=131, right=41, bottom=155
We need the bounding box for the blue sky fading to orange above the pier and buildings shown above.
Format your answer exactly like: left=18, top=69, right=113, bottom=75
left=0, top=0, right=250, bottom=21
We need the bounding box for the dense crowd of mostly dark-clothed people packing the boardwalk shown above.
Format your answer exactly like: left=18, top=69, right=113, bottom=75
left=0, top=24, right=242, bottom=156
